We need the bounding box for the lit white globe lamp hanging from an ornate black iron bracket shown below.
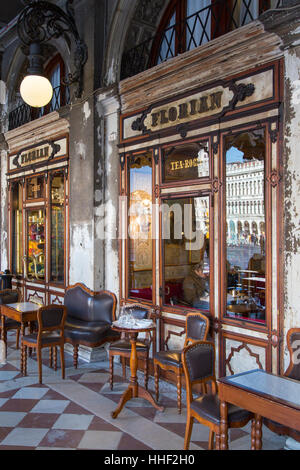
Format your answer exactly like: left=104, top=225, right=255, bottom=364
left=17, top=0, right=87, bottom=108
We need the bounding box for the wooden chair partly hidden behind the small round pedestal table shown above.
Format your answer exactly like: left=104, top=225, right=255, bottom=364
left=108, top=305, right=151, bottom=390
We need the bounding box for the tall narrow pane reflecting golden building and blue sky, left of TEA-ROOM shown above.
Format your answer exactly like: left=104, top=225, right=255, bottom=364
left=128, top=153, right=152, bottom=301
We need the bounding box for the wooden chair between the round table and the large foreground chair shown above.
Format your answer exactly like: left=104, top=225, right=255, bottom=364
left=153, top=312, right=209, bottom=413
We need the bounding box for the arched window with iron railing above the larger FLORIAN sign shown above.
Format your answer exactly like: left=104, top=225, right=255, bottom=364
left=151, top=0, right=278, bottom=65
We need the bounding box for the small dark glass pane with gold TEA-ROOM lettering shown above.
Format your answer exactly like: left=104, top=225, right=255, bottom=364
left=163, top=142, right=209, bottom=182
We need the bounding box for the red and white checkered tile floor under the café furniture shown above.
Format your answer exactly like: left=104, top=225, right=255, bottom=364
left=0, top=332, right=285, bottom=450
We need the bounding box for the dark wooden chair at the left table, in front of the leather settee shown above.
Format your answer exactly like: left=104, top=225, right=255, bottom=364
left=22, top=305, right=67, bottom=383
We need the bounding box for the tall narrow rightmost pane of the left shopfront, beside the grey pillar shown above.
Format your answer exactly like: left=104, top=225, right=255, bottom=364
left=50, top=174, right=65, bottom=282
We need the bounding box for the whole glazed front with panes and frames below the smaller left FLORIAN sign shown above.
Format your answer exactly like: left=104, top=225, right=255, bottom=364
left=10, top=169, right=67, bottom=286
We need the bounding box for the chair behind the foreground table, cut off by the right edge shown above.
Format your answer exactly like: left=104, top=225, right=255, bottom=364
left=263, top=328, right=300, bottom=442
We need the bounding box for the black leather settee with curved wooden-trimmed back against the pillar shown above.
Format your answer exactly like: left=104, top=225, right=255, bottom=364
left=64, top=283, right=120, bottom=368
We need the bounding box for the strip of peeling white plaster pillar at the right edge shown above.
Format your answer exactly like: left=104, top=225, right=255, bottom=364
left=283, top=46, right=300, bottom=369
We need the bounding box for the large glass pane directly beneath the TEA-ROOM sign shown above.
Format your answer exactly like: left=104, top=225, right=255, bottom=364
left=161, top=196, right=210, bottom=311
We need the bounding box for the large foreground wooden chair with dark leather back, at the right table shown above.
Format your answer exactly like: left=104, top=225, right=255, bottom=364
left=182, top=341, right=254, bottom=450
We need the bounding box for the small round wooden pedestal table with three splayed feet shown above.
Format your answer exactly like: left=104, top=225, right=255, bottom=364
left=111, top=325, right=164, bottom=419
